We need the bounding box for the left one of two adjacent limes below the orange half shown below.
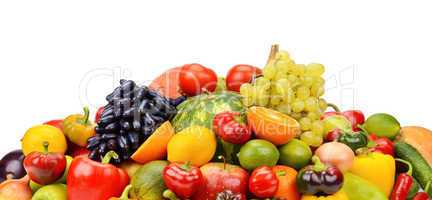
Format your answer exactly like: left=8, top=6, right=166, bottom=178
left=237, top=139, right=279, bottom=170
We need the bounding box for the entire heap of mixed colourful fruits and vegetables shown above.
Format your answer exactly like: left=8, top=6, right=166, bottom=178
left=0, top=45, right=432, bottom=200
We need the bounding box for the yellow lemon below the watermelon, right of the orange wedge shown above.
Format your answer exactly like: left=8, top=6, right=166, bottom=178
left=168, top=126, right=216, bottom=166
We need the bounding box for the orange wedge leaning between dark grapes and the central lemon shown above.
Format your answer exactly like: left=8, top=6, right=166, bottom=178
left=131, top=121, right=175, bottom=164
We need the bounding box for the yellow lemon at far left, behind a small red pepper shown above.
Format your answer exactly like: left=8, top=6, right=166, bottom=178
left=21, top=125, right=67, bottom=155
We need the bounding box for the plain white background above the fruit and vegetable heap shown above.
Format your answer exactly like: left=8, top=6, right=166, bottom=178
left=0, top=0, right=432, bottom=155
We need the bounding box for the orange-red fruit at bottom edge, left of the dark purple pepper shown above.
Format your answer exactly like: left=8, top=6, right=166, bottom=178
left=272, top=165, right=300, bottom=200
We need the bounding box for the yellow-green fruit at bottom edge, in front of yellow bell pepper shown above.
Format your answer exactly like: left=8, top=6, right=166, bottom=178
left=342, top=172, right=388, bottom=200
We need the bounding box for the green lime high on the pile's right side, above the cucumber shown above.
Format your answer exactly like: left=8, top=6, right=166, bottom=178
left=364, top=113, right=401, bottom=140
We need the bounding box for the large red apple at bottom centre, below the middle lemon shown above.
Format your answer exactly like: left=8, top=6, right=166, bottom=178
left=192, top=163, right=248, bottom=200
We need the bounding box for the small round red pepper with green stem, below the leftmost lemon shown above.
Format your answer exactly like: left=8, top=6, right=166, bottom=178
left=23, top=152, right=66, bottom=185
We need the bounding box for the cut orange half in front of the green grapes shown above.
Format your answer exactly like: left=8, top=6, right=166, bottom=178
left=247, top=106, right=300, bottom=145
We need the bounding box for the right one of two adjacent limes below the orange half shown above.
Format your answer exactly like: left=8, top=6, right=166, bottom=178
left=279, top=139, right=312, bottom=170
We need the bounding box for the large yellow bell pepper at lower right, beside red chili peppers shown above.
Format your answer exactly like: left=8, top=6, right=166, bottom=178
left=350, top=152, right=396, bottom=196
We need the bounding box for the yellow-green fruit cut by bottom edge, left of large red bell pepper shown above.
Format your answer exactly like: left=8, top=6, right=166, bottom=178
left=32, top=184, right=67, bottom=200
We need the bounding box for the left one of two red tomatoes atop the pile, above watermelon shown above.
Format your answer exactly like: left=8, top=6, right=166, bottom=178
left=179, top=63, right=217, bottom=96
